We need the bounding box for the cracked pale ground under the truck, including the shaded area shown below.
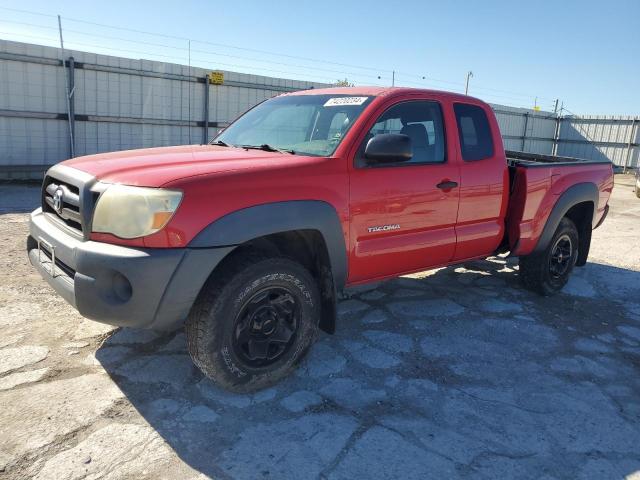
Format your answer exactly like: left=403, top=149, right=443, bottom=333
left=0, top=176, right=640, bottom=480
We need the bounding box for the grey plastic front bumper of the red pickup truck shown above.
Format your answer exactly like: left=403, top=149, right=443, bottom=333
left=27, top=209, right=234, bottom=330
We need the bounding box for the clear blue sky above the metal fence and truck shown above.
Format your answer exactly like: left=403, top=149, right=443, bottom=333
left=0, top=0, right=640, bottom=115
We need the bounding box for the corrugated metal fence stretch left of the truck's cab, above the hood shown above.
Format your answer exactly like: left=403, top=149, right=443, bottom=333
left=0, top=40, right=326, bottom=178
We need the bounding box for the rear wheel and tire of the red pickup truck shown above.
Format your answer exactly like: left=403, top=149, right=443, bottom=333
left=520, top=217, right=578, bottom=296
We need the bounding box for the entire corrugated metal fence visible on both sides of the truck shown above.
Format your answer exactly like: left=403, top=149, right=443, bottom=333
left=0, top=40, right=640, bottom=178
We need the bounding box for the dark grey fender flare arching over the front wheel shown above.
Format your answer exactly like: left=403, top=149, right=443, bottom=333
left=188, top=200, right=347, bottom=290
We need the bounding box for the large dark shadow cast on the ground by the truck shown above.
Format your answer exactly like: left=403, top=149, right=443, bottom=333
left=96, top=258, right=640, bottom=479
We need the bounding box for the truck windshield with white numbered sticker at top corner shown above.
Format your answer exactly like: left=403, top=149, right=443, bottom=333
left=212, top=95, right=372, bottom=157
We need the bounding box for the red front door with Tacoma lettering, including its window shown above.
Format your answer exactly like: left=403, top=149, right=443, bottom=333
left=349, top=100, right=460, bottom=283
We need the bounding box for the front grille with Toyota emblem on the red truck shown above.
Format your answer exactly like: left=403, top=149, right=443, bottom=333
left=42, top=176, right=84, bottom=235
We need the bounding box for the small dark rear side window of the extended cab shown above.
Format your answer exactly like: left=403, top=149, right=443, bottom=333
left=453, top=103, right=493, bottom=161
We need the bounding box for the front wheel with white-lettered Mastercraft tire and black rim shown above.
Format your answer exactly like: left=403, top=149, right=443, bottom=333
left=186, top=254, right=320, bottom=393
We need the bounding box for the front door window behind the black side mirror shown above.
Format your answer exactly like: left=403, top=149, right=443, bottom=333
left=360, top=101, right=445, bottom=166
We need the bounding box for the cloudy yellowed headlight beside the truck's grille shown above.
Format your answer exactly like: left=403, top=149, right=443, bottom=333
left=92, top=184, right=182, bottom=238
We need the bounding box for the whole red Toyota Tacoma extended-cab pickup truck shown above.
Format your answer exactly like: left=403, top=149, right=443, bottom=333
left=27, top=88, right=613, bottom=391
